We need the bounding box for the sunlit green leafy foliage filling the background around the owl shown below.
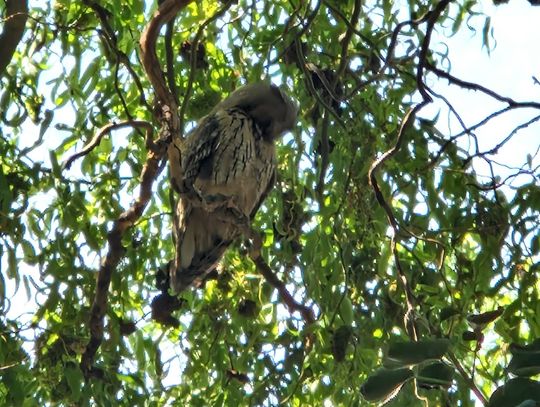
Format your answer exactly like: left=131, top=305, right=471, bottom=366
left=0, top=0, right=540, bottom=406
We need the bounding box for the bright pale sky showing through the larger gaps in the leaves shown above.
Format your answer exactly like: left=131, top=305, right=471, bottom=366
left=2, top=0, right=540, bottom=404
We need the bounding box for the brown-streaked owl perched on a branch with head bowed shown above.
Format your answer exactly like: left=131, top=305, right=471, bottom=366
left=169, top=83, right=297, bottom=293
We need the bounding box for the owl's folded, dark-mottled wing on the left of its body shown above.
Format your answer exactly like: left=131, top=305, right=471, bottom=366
left=182, top=114, right=220, bottom=186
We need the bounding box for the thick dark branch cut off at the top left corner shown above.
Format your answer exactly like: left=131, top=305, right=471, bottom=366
left=0, top=0, right=28, bottom=76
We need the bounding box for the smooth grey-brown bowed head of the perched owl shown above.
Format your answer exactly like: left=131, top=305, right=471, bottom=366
left=212, top=82, right=298, bottom=141
